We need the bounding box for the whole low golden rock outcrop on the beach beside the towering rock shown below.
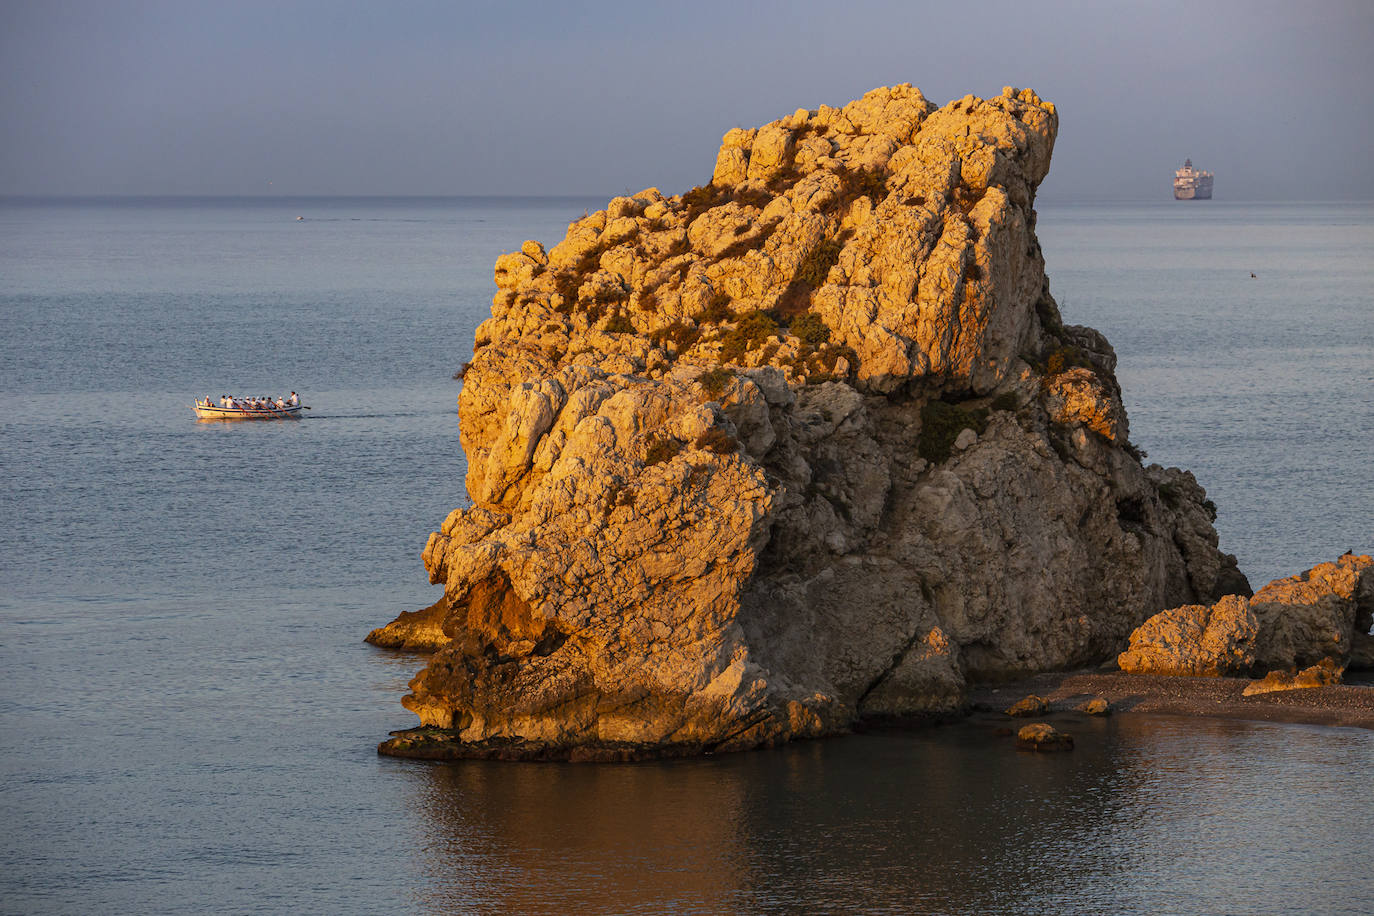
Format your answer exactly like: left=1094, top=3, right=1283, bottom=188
left=1117, top=553, right=1374, bottom=677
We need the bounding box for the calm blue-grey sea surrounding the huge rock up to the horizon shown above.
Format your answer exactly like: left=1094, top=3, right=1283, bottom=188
left=0, top=198, right=1374, bottom=915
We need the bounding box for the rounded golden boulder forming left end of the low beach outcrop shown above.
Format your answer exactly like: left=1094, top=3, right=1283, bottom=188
left=1117, top=595, right=1259, bottom=677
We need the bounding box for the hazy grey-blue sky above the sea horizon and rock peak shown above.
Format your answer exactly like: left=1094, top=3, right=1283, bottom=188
left=0, top=0, right=1374, bottom=201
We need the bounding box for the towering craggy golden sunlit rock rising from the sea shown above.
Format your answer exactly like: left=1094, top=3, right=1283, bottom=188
left=373, top=85, right=1249, bottom=755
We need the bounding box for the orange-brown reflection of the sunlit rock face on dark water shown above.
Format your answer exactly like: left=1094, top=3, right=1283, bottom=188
left=418, top=759, right=746, bottom=913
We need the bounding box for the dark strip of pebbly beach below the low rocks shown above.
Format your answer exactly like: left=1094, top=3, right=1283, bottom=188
left=970, top=670, right=1374, bottom=729
